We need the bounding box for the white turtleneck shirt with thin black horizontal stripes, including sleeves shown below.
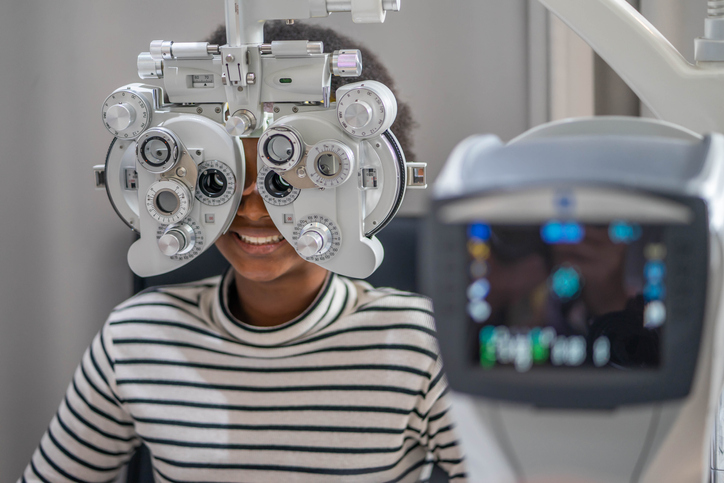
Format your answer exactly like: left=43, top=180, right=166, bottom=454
left=21, top=271, right=465, bottom=482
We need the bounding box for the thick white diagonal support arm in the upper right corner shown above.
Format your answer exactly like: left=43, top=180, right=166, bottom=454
left=540, top=0, right=724, bottom=133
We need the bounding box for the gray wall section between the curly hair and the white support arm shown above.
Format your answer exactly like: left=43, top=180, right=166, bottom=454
left=315, top=0, right=528, bottom=214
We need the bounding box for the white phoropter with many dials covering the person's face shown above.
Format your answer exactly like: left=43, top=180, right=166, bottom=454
left=94, top=0, right=426, bottom=278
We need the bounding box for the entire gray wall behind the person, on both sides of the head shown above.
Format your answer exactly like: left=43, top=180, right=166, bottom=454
left=0, top=0, right=704, bottom=481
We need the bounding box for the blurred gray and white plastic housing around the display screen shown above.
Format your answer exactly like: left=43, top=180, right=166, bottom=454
left=426, top=119, right=724, bottom=483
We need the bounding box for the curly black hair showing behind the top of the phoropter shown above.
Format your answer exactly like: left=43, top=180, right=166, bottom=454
left=207, top=21, right=416, bottom=162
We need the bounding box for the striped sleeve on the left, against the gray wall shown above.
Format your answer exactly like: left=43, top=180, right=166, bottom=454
left=19, top=324, right=140, bottom=483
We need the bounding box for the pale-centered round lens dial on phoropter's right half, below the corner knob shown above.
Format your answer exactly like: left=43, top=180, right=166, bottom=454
left=306, top=139, right=354, bottom=188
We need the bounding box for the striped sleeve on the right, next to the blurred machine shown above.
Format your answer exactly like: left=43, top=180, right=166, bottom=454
left=418, top=356, right=467, bottom=483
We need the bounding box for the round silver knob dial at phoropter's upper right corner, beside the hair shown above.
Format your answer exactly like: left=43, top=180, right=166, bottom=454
left=337, top=81, right=397, bottom=139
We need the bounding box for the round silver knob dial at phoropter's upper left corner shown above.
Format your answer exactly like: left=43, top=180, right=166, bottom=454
left=102, top=89, right=153, bottom=139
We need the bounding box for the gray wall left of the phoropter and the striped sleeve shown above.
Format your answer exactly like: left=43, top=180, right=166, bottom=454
left=0, top=0, right=224, bottom=481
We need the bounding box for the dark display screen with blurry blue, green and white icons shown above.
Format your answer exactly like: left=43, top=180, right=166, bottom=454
left=466, top=220, right=667, bottom=372
